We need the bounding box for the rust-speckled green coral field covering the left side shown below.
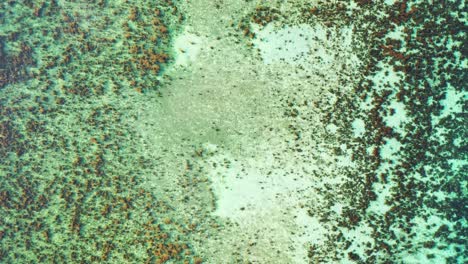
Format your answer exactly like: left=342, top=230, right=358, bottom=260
left=0, top=0, right=201, bottom=263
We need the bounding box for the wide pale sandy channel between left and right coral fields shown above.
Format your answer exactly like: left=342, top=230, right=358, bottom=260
left=139, top=0, right=368, bottom=264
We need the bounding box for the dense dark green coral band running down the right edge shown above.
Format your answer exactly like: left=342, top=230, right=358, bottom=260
left=310, top=1, right=468, bottom=263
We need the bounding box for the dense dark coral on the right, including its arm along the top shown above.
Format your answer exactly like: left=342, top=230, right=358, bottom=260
left=243, top=0, right=468, bottom=263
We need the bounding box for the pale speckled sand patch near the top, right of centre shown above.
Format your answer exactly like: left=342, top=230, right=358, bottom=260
left=251, top=23, right=360, bottom=72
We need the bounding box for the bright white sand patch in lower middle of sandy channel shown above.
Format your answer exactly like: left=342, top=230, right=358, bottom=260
left=207, top=148, right=313, bottom=219
